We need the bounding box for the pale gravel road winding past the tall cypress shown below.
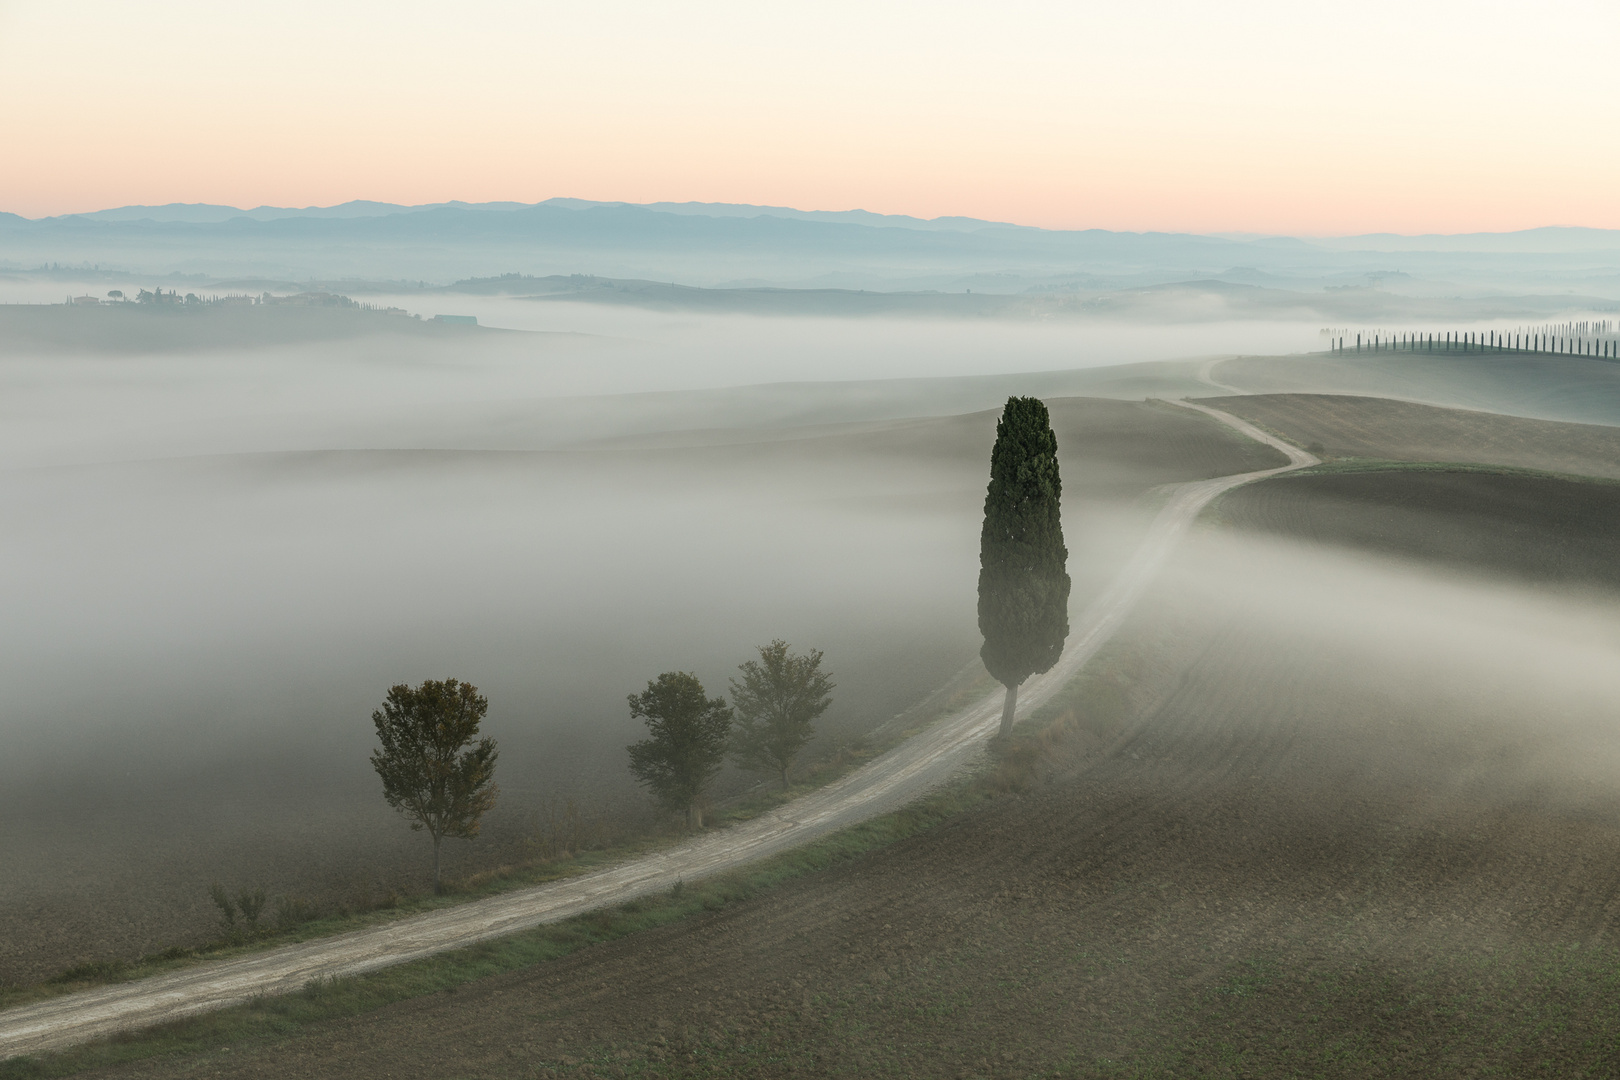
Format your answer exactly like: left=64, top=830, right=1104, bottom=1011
left=0, top=402, right=1317, bottom=1061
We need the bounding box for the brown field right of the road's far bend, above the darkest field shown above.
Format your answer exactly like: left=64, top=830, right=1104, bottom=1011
left=1199, top=393, right=1620, bottom=478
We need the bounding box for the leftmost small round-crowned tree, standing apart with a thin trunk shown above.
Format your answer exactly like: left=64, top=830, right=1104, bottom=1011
left=371, top=678, right=499, bottom=889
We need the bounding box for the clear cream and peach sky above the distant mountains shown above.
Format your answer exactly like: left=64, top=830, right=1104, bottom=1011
left=0, top=0, right=1620, bottom=235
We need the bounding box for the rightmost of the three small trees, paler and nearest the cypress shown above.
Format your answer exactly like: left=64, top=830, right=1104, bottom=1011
left=731, top=640, right=833, bottom=787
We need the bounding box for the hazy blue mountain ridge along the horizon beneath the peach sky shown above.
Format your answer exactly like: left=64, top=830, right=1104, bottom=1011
left=9, top=199, right=1620, bottom=284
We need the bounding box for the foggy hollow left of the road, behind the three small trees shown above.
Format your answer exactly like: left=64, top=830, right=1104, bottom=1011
left=0, top=395, right=1166, bottom=978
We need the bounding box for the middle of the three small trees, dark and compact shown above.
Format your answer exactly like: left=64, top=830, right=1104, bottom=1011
left=629, top=672, right=731, bottom=829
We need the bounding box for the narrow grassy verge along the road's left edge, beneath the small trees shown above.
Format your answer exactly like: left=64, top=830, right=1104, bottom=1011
left=0, top=669, right=995, bottom=1009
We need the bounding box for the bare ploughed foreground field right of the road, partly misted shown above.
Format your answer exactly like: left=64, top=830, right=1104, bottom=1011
left=66, top=453, right=1620, bottom=1078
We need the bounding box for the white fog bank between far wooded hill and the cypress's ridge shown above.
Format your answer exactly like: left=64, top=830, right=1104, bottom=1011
left=0, top=298, right=1319, bottom=466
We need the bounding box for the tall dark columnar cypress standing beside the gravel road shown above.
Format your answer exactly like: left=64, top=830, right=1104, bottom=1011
left=978, top=397, right=1069, bottom=733
